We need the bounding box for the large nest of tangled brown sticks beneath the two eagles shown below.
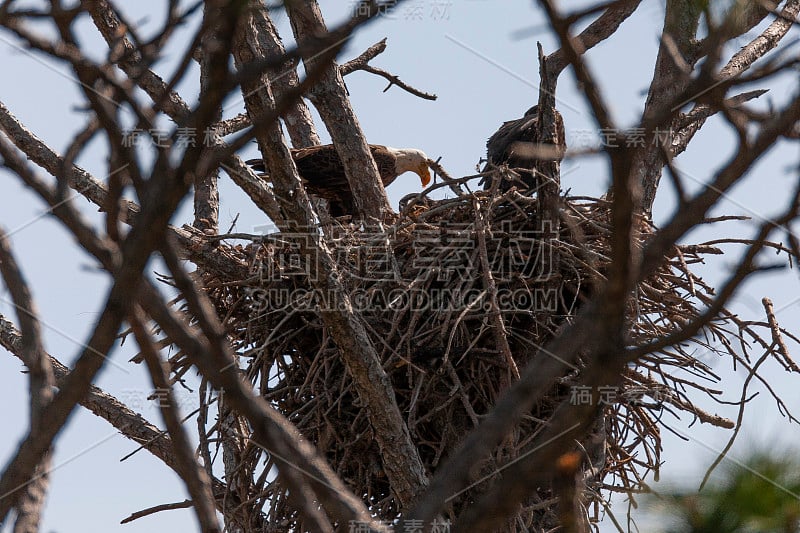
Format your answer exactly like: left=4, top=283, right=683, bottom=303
left=183, top=172, right=768, bottom=529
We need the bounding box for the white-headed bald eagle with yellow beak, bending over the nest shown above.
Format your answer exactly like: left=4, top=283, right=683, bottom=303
left=247, top=144, right=431, bottom=217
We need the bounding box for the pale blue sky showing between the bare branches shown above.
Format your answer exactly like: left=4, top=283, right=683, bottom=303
left=0, top=0, right=800, bottom=533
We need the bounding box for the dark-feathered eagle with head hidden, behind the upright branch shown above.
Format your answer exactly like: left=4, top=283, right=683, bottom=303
left=483, top=105, right=566, bottom=190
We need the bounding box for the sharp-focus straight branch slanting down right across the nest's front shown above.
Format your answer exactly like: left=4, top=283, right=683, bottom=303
left=234, top=0, right=427, bottom=506
